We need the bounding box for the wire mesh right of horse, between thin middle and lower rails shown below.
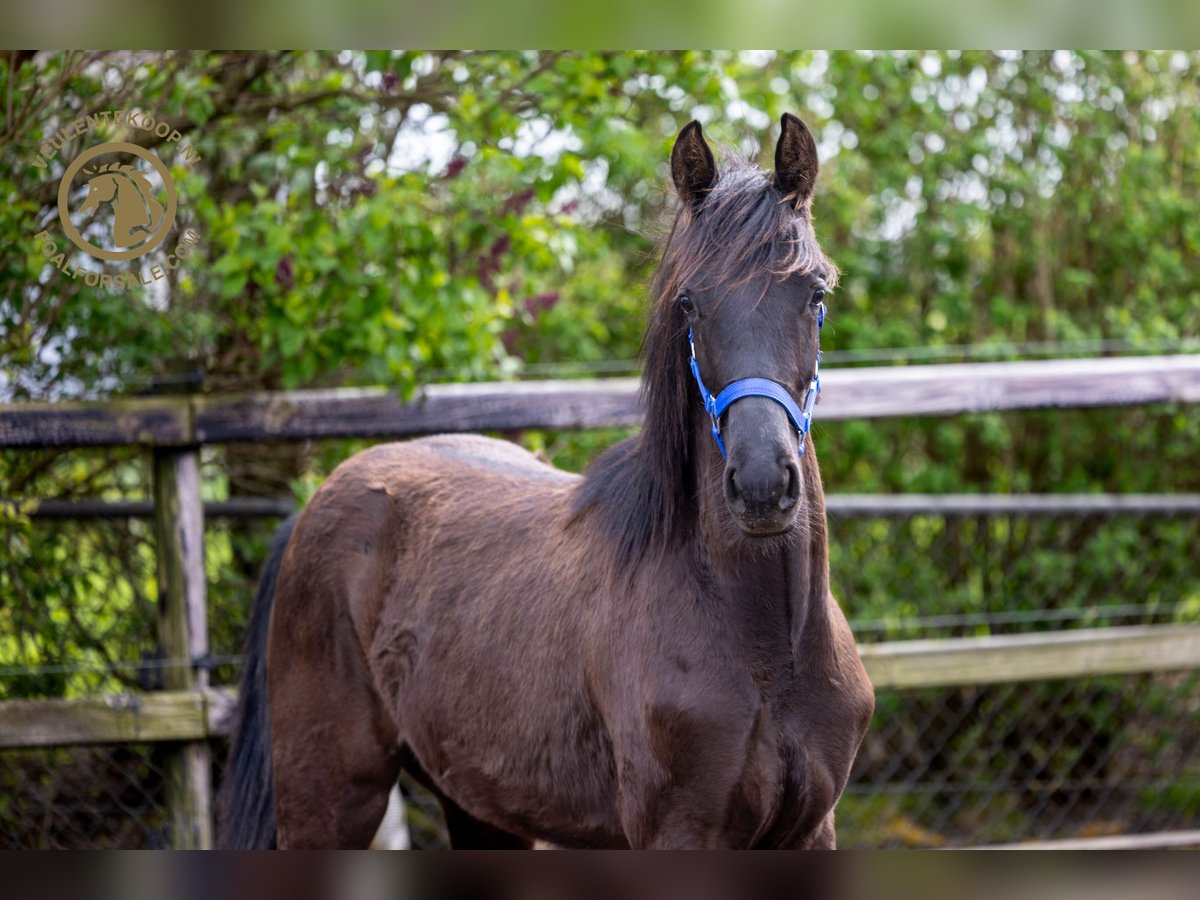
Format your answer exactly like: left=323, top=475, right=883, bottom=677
left=829, top=497, right=1200, bottom=643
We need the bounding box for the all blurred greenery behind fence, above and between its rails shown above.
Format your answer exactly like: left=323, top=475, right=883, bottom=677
left=0, top=50, right=1200, bottom=849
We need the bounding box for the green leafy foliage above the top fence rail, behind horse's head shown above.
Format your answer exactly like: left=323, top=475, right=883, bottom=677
left=9, top=52, right=1200, bottom=396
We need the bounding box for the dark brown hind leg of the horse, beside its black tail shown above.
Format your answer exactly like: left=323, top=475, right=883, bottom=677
left=268, top=580, right=400, bottom=848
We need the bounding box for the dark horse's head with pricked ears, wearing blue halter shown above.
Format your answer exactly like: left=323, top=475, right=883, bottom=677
left=656, top=115, right=836, bottom=536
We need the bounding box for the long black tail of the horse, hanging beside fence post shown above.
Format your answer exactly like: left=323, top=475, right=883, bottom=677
left=217, top=516, right=296, bottom=850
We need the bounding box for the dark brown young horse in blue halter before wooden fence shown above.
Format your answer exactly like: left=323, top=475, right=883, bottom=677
left=221, top=115, right=875, bottom=848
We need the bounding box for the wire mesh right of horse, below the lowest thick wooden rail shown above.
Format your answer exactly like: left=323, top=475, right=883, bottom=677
left=838, top=671, right=1200, bottom=847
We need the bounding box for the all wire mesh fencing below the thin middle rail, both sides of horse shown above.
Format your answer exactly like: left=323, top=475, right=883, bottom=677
left=0, top=498, right=1200, bottom=848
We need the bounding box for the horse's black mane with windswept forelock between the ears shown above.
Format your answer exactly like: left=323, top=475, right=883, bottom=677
left=575, top=153, right=838, bottom=566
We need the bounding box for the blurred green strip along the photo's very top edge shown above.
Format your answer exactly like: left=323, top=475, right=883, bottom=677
left=0, top=0, right=1200, bottom=49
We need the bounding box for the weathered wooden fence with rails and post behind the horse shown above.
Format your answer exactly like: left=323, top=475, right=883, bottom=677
left=0, top=355, right=1200, bottom=847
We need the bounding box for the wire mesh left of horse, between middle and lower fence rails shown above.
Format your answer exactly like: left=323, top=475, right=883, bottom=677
left=0, top=518, right=275, bottom=700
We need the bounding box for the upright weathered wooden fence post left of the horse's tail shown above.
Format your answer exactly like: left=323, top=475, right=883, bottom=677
left=154, top=448, right=212, bottom=850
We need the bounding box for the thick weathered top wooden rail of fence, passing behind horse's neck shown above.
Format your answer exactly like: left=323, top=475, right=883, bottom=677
left=0, top=354, right=1200, bottom=448
